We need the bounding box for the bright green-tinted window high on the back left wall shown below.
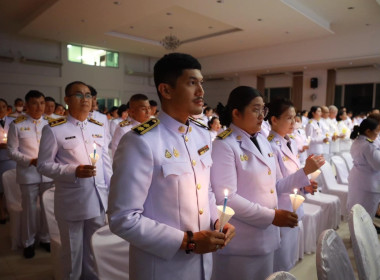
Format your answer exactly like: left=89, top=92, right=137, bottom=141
left=67, top=44, right=119, bottom=68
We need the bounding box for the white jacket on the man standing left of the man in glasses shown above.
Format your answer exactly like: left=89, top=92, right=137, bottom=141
left=8, top=115, right=53, bottom=184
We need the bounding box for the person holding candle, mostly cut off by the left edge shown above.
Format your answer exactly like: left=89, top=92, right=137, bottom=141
left=0, top=98, right=16, bottom=224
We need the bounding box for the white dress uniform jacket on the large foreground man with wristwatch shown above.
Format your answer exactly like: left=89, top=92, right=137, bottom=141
left=108, top=112, right=217, bottom=279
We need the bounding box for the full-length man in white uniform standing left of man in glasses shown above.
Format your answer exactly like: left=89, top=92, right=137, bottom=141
left=8, top=90, right=53, bottom=258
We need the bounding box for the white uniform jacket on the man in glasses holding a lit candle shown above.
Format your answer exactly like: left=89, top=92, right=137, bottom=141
left=38, top=115, right=112, bottom=221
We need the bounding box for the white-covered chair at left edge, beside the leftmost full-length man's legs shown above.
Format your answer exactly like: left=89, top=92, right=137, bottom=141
left=2, top=169, right=22, bottom=250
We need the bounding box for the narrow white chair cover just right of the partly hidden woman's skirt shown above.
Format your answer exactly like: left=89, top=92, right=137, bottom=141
left=302, top=203, right=322, bottom=254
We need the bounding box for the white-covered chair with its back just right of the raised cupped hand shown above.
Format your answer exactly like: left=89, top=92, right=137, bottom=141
left=320, top=162, right=348, bottom=220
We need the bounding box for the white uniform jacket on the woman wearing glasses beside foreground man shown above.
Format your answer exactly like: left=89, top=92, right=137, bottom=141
left=211, top=124, right=309, bottom=258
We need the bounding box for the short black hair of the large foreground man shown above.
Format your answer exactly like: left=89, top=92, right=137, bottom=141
left=154, top=53, right=202, bottom=100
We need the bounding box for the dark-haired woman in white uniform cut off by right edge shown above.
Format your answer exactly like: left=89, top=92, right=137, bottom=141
left=347, top=117, right=380, bottom=220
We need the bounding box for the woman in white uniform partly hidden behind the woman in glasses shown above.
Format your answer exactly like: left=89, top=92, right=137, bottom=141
left=268, top=99, right=323, bottom=271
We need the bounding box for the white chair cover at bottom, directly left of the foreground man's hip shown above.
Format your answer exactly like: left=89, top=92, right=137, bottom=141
left=91, top=225, right=129, bottom=280
